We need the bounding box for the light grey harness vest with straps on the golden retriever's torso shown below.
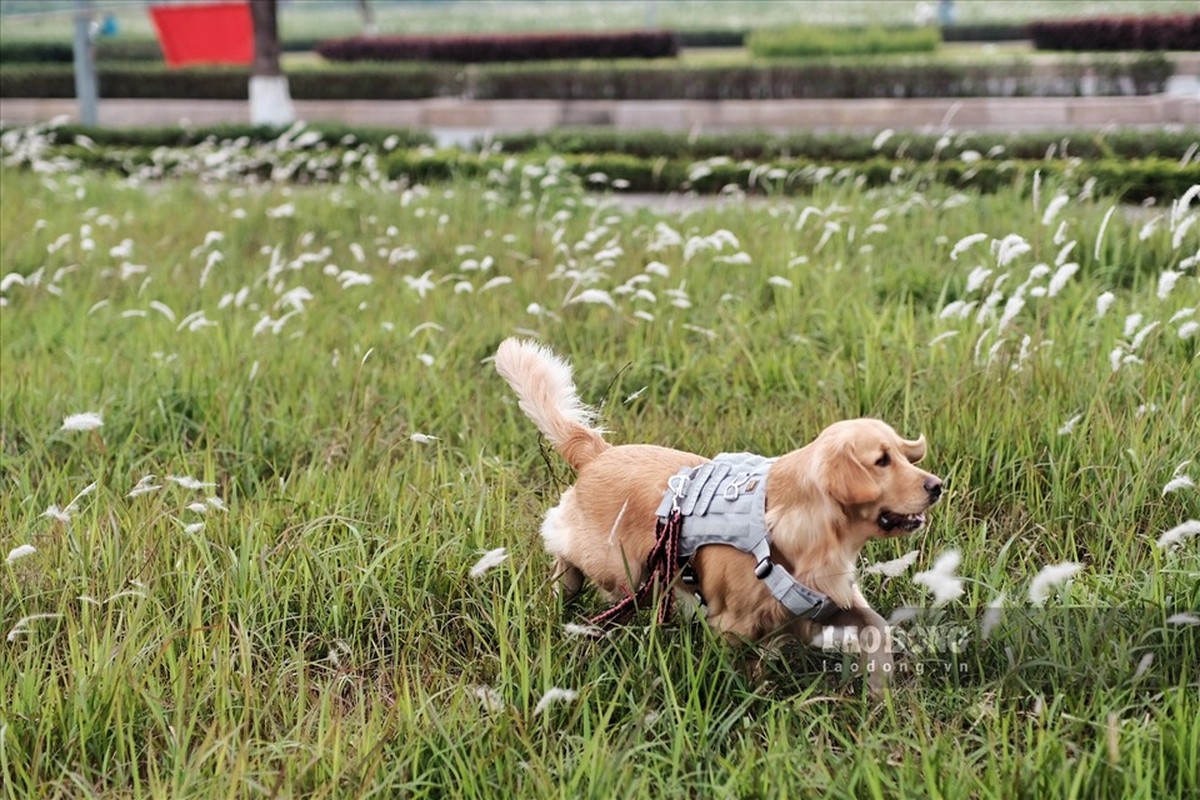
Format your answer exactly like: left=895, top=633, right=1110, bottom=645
left=658, top=453, right=841, bottom=621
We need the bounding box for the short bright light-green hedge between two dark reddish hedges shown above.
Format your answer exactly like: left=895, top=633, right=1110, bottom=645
left=746, top=25, right=942, bottom=59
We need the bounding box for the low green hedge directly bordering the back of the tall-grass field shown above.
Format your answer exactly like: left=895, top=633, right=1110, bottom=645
left=7, top=128, right=1200, bottom=201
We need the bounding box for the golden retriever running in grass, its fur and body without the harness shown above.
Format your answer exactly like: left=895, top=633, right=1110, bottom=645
left=496, top=338, right=942, bottom=696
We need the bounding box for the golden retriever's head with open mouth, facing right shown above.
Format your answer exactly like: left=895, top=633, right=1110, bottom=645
left=810, top=420, right=942, bottom=537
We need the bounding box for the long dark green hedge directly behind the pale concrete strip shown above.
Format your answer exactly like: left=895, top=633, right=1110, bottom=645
left=0, top=54, right=1175, bottom=100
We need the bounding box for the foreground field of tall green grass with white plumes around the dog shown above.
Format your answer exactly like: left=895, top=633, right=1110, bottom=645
left=0, top=145, right=1200, bottom=799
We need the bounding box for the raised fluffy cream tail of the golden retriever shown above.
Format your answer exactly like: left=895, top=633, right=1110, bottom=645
left=496, top=338, right=612, bottom=471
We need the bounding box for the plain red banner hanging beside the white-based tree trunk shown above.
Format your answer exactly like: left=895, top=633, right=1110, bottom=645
left=150, top=2, right=254, bottom=67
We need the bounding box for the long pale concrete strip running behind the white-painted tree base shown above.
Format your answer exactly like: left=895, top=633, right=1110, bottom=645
left=0, top=92, right=1200, bottom=136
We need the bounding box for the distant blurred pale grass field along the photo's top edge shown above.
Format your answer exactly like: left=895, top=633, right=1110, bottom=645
left=2, top=0, right=1194, bottom=40
